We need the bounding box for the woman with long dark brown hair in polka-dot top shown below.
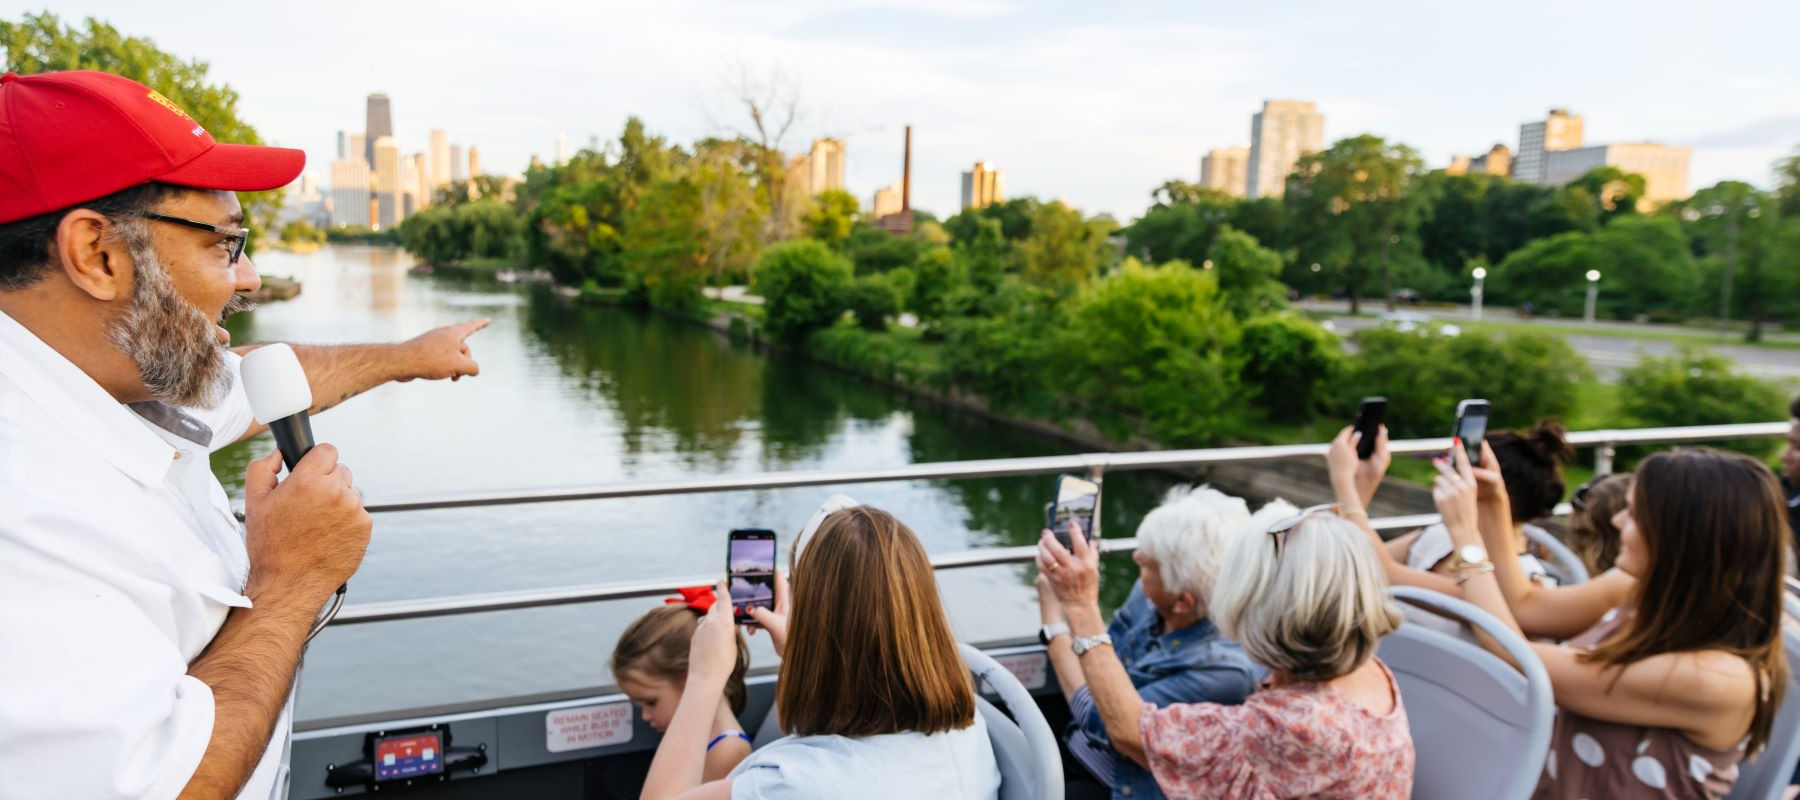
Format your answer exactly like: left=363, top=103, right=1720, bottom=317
left=1433, top=447, right=1787, bottom=800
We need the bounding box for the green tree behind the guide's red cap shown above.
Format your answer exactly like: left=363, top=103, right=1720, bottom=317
left=0, top=13, right=283, bottom=229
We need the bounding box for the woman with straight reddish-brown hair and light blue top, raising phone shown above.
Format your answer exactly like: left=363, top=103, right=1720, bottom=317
left=643, top=506, right=1001, bottom=800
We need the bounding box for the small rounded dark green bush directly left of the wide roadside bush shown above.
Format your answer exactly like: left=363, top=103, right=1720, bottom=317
left=1237, top=314, right=1345, bottom=422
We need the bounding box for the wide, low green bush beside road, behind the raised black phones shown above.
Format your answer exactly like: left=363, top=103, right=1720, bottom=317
left=1336, top=328, right=1593, bottom=438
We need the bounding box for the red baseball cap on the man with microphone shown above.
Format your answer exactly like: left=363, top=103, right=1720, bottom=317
left=0, top=70, right=306, bottom=223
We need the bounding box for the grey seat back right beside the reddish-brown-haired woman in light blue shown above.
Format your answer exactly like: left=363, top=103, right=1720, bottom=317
left=956, top=645, right=1064, bottom=800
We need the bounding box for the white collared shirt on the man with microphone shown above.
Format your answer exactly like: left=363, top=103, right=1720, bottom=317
left=0, top=314, right=293, bottom=800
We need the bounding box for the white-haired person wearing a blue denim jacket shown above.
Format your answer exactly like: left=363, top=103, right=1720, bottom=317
left=1037, top=486, right=1264, bottom=800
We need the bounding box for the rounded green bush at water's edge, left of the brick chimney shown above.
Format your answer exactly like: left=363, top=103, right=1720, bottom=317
left=751, top=240, right=853, bottom=342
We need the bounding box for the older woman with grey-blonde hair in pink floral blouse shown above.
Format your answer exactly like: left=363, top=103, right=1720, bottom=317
left=1037, top=501, right=1413, bottom=800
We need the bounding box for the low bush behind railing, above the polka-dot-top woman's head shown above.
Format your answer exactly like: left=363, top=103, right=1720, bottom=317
left=1618, top=344, right=1787, bottom=461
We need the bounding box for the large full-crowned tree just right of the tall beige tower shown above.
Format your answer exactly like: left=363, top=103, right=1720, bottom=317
left=1283, top=133, right=1424, bottom=312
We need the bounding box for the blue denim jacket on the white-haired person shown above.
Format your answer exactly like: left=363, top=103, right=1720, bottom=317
left=1069, top=582, right=1267, bottom=800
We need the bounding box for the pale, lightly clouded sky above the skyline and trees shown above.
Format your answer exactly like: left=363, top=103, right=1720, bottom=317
left=0, top=0, right=1800, bottom=220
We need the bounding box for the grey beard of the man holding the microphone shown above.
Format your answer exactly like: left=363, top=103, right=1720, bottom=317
left=106, top=243, right=256, bottom=409
